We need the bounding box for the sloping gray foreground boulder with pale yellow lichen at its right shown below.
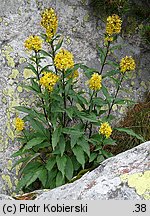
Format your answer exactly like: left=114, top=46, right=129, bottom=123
left=36, top=141, right=150, bottom=200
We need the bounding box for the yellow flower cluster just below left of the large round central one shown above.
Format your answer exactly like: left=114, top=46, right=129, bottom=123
left=40, top=72, right=59, bottom=92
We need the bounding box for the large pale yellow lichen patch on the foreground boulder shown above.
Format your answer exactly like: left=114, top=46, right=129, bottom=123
left=120, top=170, right=150, bottom=200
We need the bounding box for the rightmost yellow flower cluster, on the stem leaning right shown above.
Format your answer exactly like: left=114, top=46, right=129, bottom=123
left=120, top=56, right=135, bottom=73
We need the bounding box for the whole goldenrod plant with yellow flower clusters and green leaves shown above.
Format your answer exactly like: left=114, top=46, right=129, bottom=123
left=13, top=8, right=143, bottom=191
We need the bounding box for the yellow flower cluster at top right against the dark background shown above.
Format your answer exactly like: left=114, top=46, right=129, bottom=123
left=106, top=14, right=122, bottom=35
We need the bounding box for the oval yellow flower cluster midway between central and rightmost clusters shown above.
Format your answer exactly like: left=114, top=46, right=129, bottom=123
left=88, top=73, right=102, bottom=91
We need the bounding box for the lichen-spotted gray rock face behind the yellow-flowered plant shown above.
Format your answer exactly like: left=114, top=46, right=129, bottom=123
left=0, top=0, right=150, bottom=194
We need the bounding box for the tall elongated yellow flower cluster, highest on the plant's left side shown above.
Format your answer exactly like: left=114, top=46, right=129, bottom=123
left=41, top=8, right=58, bottom=41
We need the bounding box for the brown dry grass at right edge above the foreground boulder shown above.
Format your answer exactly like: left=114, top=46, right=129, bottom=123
left=106, top=92, right=150, bottom=155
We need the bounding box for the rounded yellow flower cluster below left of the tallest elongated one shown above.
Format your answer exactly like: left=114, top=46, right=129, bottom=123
left=24, top=35, right=42, bottom=52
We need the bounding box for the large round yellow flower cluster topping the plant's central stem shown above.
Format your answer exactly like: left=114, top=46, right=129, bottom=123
left=54, top=49, right=74, bottom=70
